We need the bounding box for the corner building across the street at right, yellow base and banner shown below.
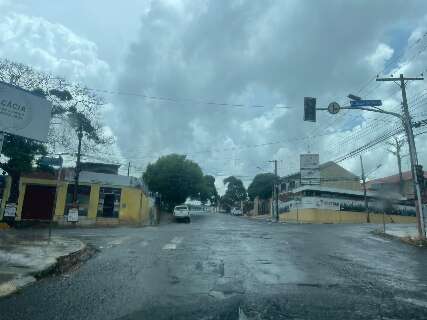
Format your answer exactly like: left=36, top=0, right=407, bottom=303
left=272, top=162, right=415, bottom=223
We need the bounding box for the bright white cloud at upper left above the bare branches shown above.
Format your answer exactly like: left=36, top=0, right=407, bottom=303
left=0, top=14, right=112, bottom=86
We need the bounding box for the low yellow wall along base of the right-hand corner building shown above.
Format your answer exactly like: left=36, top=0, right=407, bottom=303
left=280, top=209, right=416, bottom=223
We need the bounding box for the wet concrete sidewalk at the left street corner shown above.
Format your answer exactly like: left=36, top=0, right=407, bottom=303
left=0, top=230, right=86, bottom=297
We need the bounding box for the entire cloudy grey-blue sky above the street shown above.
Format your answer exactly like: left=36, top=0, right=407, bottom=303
left=0, top=0, right=427, bottom=192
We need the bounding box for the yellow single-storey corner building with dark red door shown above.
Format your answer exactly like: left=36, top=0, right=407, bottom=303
left=11, top=170, right=155, bottom=224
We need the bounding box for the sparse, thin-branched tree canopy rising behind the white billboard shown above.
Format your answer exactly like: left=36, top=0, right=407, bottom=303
left=0, top=59, right=113, bottom=155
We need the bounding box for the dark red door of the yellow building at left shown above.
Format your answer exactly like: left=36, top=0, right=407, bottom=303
left=21, top=185, right=56, bottom=220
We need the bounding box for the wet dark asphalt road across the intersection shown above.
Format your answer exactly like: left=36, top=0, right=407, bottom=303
left=0, top=214, right=427, bottom=320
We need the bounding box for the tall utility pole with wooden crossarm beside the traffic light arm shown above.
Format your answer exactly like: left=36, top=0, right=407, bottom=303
left=377, top=74, right=426, bottom=238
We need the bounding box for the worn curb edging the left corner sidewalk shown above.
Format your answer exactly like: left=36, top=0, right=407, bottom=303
left=0, top=242, right=97, bottom=299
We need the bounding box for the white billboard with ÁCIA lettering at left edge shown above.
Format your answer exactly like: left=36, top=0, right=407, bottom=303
left=0, top=81, right=52, bottom=141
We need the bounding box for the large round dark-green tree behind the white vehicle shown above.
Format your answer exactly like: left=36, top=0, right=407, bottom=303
left=143, top=154, right=203, bottom=210
